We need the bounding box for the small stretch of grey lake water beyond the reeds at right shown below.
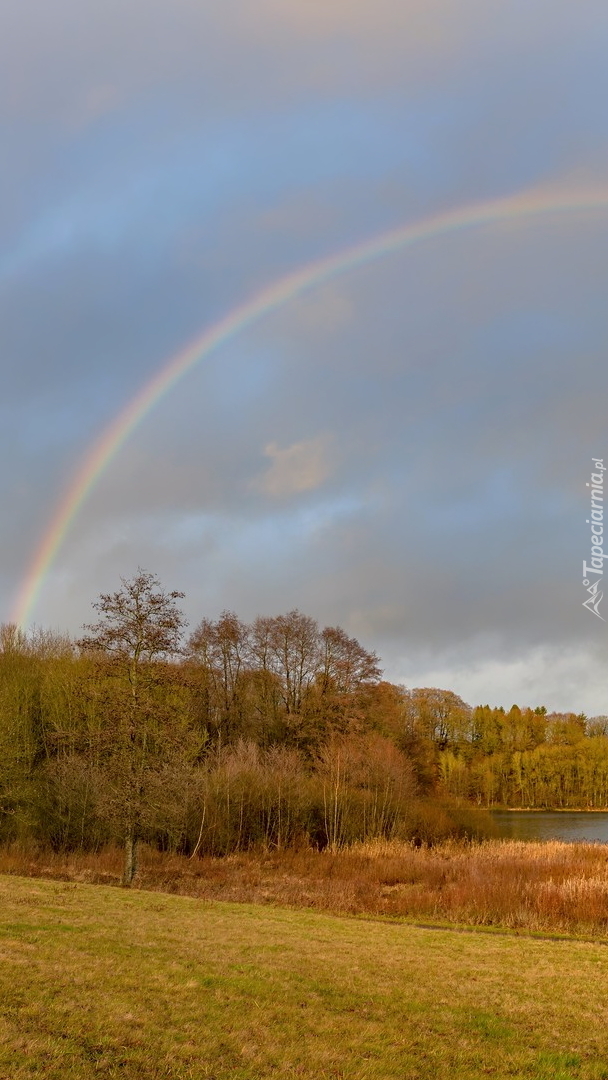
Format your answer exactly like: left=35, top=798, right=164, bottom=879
left=491, top=810, right=608, bottom=843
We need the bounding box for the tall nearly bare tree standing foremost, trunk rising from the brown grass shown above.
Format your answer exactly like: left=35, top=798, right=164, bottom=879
left=79, top=569, right=186, bottom=887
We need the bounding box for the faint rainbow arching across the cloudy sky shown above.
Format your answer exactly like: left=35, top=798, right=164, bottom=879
left=11, top=181, right=608, bottom=629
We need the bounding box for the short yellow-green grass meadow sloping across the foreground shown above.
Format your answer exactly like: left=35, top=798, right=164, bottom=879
left=0, top=877, right=608, bottom=1080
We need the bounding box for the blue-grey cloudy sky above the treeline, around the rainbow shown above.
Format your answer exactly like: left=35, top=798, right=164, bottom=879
left=0, top=0, right=608, bottom=714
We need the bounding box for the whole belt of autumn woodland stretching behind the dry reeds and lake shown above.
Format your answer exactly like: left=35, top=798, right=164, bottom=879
left=0, top=570, right=608, bottom=883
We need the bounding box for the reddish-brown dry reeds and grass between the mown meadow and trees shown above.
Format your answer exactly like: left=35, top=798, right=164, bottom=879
left=0, top=840, right=608, bottom=935
